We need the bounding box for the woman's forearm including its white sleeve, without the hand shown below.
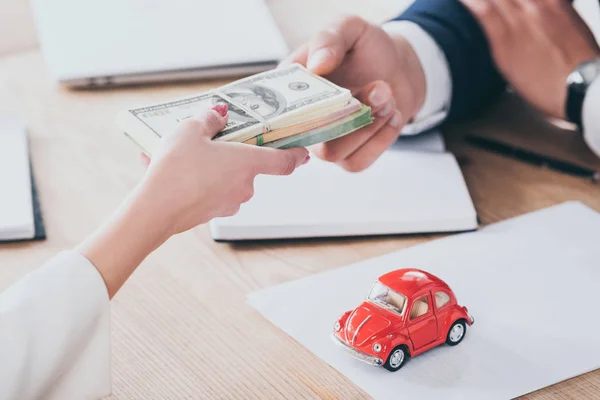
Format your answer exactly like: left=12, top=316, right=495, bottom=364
left=0, top=185, right=164, bottom=399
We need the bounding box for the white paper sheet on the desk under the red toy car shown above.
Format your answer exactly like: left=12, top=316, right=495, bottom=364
left=249, top=202, right=600, bottom=400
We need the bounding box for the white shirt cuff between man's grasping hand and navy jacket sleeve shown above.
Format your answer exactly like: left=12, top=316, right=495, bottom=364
left=383, top=21, right=452, bottom=135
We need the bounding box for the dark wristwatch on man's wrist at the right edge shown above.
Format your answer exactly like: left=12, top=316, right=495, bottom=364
left=565, top=58, right=600, bottom=130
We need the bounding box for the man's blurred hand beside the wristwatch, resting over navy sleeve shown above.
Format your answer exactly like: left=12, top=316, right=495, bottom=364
left=461, top=0, right=600, bottom=119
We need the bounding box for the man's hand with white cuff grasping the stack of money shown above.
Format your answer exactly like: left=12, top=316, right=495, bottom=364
left=284, top=17, right=425, bottom=171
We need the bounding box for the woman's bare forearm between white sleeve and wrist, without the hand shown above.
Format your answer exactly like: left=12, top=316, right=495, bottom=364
left=78, top=185, right=171, bottom=298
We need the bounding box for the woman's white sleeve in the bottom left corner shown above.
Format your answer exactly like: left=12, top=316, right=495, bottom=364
left=0, top=252, right=111, bottom=400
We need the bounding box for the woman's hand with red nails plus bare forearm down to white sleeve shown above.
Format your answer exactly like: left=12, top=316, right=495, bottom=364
left=80, top=105, right=309, bottom=298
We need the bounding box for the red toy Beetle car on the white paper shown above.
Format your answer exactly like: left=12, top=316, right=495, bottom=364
left=333, top=269, right=474, bottom=371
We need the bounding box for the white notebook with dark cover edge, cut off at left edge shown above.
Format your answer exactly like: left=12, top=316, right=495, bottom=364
left=0, top=114, right=45, bottom=241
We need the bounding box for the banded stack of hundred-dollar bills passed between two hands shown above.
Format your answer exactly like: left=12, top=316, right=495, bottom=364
left=117, top=64, right=373, bottom=155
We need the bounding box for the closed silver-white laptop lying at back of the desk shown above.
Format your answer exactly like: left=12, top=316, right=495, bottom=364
left=31, top=0, right=288, bottom=87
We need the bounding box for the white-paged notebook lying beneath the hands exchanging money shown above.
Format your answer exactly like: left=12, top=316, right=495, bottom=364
left=210, top=133, right=477, bottom=241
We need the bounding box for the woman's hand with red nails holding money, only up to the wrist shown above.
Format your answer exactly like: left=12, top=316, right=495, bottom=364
left=139, top=105, right=309, bottom=234
